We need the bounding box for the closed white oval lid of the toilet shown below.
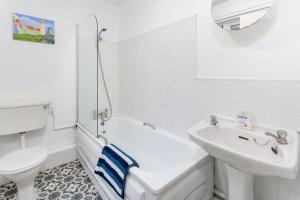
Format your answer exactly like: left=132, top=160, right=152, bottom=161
left=0, top=147, right=47, bottom=174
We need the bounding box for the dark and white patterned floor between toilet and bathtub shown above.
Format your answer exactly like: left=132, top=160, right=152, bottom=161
left=0, top=160, right=101, bottom=200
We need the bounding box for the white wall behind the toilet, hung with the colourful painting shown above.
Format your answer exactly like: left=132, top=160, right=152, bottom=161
left=0, top=0, right=119, bottom=179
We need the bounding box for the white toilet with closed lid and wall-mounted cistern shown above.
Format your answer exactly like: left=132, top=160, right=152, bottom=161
left=0, top=99, right=50, bottom=200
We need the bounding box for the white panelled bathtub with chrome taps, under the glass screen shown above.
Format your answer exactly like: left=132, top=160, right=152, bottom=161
left=77, top=116, right=213, bottom=200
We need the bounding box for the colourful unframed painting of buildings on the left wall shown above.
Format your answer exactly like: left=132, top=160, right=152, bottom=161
left=13, top=13, right=55, bottom=44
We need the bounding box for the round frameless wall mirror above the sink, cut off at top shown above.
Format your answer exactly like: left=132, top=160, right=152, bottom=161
left=211, top=0, right=274, bottom=30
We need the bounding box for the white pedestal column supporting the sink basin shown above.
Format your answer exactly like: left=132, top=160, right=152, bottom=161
left=226, top=164, right=254, bottom=200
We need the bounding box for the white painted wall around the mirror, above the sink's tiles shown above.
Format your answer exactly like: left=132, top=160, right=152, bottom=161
left=198, top=0, right=300, bottom=81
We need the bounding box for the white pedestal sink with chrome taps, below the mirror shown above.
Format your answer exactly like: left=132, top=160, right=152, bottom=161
left=189, top=117, right=298, bottom=200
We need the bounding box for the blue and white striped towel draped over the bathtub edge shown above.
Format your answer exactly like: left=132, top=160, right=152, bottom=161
left=95, top=144, right=139, bottom=199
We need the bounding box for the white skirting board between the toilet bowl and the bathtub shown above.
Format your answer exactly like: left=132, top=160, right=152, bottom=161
left=0, top=144, right=76, bottom=185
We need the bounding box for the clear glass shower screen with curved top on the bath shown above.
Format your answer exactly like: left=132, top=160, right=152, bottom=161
left=77, top=15, right=99, bottom=136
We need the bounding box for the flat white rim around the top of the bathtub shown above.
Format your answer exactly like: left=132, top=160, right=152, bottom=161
left=76, top=114, right=212, bottom=194
